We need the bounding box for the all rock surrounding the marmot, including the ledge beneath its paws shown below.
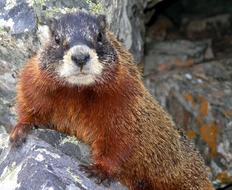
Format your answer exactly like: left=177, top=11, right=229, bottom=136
left=0, top=0, right=232, bottom=190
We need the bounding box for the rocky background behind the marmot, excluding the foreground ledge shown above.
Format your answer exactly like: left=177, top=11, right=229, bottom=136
left=0, top=0, right=232, bottom=187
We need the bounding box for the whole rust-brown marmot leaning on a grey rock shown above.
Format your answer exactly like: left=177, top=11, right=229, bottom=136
left=10, top=12, right=213, bottom=190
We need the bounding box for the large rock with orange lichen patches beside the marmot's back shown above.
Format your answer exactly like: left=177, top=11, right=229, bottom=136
left=145, top=59, right=232, bottom=187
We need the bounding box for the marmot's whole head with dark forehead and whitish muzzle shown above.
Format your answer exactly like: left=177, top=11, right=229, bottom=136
left=39, top=12, right=117, bottom=86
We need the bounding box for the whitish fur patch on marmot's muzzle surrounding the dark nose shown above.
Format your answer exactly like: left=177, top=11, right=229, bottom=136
left=58, top=45, right=103, bottom=85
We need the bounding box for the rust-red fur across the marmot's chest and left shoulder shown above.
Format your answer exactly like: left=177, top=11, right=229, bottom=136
left=17, top=57, right=136, bottom=143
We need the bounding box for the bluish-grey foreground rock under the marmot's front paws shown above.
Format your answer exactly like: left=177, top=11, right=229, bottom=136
left=0, top=127, right=126, bottom=190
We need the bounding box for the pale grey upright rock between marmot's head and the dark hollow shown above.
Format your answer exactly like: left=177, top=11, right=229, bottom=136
left=100, top=0, right=148, bottom=63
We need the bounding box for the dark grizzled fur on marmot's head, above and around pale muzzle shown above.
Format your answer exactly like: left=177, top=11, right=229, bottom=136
left=40, top=11, right=117, bottom=76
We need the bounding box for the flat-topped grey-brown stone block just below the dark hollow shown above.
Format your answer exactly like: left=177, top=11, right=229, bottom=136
left=144, top=40, right=214, bottom=75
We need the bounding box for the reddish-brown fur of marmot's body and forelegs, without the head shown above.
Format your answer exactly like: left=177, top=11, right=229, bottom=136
left=11, top=33, right=213, bottom=190
